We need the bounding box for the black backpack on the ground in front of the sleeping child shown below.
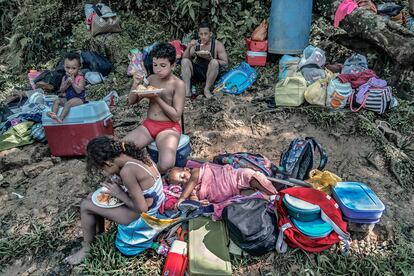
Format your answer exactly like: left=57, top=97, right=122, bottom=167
left=222, top=199, right=278, bottom=256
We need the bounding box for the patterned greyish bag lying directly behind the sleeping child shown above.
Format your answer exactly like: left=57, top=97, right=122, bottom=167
left=213, top=152, right=274, bottom=176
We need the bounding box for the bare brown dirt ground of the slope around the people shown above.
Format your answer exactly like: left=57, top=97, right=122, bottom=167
left=0, top=85, right=414, bottom=275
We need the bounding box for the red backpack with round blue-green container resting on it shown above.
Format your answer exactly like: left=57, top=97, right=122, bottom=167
left=275, top=187, right=350, bottom=253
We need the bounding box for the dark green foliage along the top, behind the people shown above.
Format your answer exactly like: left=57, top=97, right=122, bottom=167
left=0, top=0, right=271, bottom=72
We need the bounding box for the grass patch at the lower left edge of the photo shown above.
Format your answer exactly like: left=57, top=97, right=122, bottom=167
left=0, top=212, right=76, bottom=271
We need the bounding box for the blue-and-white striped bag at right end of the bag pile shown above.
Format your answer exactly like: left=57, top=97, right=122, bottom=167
left=349, top=86, right=394, bottom=114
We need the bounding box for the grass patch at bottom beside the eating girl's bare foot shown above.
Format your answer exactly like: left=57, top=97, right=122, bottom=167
left=76, top=227, right=163, bottom=275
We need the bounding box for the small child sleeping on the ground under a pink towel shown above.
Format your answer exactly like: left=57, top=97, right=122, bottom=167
left=167, top=163, right=277, bottom=206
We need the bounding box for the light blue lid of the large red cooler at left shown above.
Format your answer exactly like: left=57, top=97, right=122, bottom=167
left=42, top=101, right=112, bottom=126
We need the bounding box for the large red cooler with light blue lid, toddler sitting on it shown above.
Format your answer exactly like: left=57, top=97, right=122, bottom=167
left=42, top=101, right=114, bottom=156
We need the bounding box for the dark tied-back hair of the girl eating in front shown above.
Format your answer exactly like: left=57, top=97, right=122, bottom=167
left=86, top=136, right=151, bottom=172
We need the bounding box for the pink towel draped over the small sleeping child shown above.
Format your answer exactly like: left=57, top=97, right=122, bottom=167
left=195, top=163, right=277, bottom=203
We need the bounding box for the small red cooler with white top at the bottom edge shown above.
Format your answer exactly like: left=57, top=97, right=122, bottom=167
left=162, top=240, right=188, bottom=276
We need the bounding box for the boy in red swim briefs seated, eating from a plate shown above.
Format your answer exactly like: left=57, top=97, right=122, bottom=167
left=124, top=43, right=185, bottom=173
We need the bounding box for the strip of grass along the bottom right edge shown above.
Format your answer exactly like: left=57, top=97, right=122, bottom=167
left=236, top=243, right=414, bottom=275
